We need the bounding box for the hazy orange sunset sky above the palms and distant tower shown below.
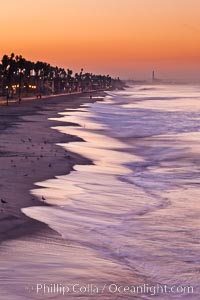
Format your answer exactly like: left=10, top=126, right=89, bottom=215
left=0, top=0, right=200, bottom=78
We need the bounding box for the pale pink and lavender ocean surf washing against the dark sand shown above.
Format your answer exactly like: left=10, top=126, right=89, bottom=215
left=23, top=84, right=200, bottom=299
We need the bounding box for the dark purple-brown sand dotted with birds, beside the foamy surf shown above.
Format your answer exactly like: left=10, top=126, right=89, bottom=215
left=0, top=91, right=105, bottom=244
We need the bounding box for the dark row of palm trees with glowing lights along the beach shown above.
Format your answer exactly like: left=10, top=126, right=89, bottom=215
left=0, top=53, right=116, bottom=100
